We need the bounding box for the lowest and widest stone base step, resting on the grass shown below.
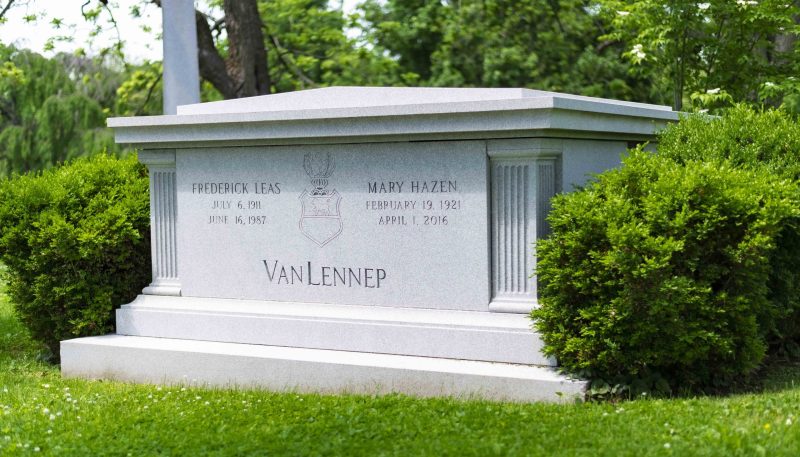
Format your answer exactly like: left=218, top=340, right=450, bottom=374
left=61, top=335, right=586, bottom=402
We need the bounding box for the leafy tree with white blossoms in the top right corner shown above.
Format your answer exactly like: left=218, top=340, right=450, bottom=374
left=598, top=0, right=800, bottom=110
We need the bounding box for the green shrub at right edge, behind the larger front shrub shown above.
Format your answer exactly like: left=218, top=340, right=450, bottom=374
left=658, top=106, right=800, bottom=354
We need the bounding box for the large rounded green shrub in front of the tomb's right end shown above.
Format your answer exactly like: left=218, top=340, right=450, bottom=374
left=532, top=150, right=800, bottom=388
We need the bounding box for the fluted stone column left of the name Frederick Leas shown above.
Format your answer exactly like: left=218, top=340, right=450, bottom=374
left=139, top=149, right=181, bottom=296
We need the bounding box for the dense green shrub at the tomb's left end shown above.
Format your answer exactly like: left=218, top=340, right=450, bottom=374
left=0, top=155, right=150, bottom=357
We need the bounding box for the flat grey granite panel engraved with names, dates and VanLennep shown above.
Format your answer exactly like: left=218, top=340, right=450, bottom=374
left=176, top=141, right=491, bottom=311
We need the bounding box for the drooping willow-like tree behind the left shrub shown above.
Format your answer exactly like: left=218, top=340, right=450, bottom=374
left=0, top=45, right=116, bottom=176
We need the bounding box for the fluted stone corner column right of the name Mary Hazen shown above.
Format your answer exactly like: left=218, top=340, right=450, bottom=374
left=489, top=140, right=561, bottom=313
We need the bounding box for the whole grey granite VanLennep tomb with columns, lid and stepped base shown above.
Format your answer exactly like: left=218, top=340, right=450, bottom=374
left=61, top=87, right=677, bottom=401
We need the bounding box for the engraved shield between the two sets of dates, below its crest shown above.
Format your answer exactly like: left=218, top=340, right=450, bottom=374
left=300, top=190, right=342, bottom=247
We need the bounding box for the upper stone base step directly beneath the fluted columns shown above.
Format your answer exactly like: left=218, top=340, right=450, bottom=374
left=117, top=295, right=556, bottom=366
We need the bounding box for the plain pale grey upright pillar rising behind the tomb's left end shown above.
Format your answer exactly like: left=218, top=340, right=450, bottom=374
left=161, top=0, right=200, bottom=114
